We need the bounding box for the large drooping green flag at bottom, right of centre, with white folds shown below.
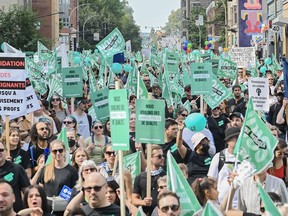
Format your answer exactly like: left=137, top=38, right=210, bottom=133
left=167, top=151, right=202, bottom=216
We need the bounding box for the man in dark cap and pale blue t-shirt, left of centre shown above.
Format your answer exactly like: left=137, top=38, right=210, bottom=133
left=73, top=98, right=92, bottom=140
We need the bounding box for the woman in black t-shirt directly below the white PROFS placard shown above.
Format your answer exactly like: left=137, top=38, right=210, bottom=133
left=2, top=128, right=32, bottom=178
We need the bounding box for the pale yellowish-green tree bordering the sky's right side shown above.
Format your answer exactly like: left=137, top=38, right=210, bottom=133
left=164, top=9, right=182, bottom=35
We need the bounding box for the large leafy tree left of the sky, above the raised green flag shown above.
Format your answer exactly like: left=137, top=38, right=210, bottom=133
left=79, top=0, right=141, bottom=51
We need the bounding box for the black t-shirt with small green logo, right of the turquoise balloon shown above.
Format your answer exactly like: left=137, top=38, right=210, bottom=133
left=207, top=115, right=229, bottom=152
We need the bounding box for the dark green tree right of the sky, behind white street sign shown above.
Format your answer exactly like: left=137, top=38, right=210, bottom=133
left=187, top=6, right=207, bottom=50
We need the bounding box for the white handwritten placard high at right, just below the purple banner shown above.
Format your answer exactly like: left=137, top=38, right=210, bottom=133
left=229, top=47, right=256, bottom=68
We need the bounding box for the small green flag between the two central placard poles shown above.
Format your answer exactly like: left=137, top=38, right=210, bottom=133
left=123, top=151, right=141, bottom=185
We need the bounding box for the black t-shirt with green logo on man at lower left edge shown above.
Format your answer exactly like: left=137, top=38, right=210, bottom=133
left=0, top=161, right=30, bottom=212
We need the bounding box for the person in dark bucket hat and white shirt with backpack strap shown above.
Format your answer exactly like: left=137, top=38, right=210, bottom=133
left=207, top=127, right=241, bottom=207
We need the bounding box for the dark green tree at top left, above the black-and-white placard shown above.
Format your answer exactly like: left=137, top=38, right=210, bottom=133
left=0, top=6, right=49, bottom=51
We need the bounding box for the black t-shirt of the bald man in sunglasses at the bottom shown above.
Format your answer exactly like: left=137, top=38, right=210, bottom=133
left=82, top=204, right=129, bottom=216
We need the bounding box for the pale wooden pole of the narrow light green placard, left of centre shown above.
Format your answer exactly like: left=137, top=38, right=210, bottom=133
left=110, top=81, right=126, bottom=216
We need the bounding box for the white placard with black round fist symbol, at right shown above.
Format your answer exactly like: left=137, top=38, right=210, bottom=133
left=248, top=77, right=270, bottom=112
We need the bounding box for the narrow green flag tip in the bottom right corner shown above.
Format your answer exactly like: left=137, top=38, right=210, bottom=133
left=257, top=182, right=281, bottom=216
